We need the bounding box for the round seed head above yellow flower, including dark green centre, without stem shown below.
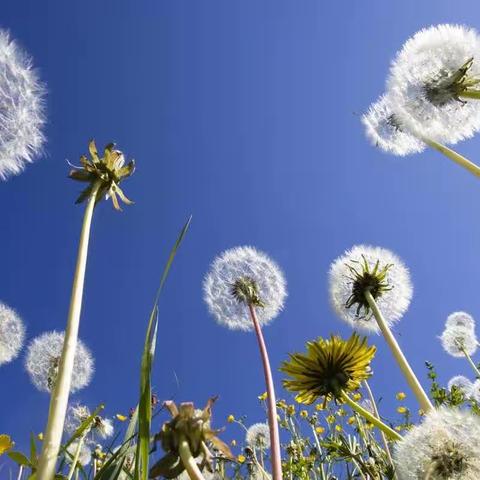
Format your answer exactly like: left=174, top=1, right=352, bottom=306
left=329, top=245, right=413, bottom=332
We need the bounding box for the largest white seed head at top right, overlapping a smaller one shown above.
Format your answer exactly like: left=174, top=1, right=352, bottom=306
left=387, top=24, right=480, bottom=144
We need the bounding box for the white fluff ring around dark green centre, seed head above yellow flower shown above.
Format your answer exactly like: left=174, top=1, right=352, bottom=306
left=329, top=245, right=413, bottom=333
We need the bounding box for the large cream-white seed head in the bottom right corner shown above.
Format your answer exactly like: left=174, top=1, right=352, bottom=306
left=394, top=407, right=480, bottom=480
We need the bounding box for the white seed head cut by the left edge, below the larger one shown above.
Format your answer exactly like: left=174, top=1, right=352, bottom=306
left=0, top=303, right=25, bottom=365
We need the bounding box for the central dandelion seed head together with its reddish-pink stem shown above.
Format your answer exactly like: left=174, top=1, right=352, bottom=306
left=203, top=247, right=287, bottom=480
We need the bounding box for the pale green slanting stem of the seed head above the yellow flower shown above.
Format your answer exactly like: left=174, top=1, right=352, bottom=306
left=365, top=291, right=433, bottom=413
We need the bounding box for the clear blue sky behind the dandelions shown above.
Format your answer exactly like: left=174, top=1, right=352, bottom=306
left=0, top=0, right=480, bottom=462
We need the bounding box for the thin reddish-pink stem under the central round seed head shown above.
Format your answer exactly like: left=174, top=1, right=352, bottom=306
left=249, top=305, right=282, bottom=480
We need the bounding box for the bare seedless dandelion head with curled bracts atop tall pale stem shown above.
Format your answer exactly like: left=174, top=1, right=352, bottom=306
left=69, top=140, right=135, bottom=210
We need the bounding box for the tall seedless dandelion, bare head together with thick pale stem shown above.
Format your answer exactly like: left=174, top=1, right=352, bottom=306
left=37, top=141, right=135, bottom=480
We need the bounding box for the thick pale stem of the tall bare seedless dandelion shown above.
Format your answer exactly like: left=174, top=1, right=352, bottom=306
left=37, top=183, right=100, bottom=480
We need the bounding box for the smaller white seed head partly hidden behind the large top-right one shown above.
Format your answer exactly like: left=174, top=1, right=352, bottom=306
left=362, top=95, right=425, bottom=157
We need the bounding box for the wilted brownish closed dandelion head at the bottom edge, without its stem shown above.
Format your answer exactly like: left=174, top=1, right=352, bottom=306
left=149, top=398, right=233, bottom=478
